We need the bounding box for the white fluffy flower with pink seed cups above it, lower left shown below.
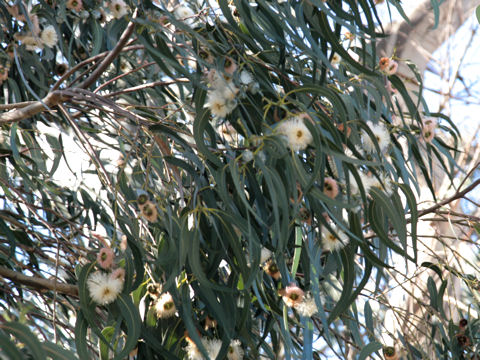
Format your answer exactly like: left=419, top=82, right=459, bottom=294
left=87, top=247, right=125, bottom=305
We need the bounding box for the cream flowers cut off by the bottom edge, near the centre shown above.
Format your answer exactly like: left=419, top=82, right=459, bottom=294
left=184, top=336, right=244, bottom=360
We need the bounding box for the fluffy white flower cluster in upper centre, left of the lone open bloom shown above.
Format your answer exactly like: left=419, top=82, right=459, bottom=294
left=205, top=57, right=258, bottom=118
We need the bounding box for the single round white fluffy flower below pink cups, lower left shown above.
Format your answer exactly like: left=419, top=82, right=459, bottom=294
left=87, top=271, right=123, bottom=305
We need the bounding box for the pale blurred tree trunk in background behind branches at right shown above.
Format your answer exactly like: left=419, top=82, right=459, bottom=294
left=377, top=0, right=478, bottom=356
